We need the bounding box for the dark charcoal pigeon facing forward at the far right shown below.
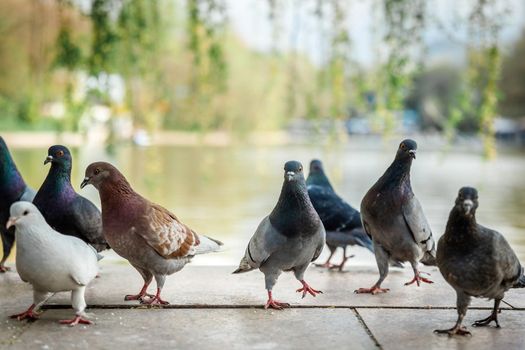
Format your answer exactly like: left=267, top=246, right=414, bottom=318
left=435, top=187, right=525, bottom=335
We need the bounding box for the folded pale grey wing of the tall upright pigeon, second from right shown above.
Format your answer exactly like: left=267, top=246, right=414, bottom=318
left=402, top=196, right=436, bottom=257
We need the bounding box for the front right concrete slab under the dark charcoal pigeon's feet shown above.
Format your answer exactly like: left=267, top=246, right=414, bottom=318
left=357, top=309, right=525, bottom=350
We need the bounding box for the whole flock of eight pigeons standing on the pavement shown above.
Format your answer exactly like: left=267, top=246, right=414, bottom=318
left=0, top=137, right=525, bottom=335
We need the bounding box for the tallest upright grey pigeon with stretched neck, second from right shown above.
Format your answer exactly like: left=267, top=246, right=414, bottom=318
left=355, top=139, right=436, bottom=294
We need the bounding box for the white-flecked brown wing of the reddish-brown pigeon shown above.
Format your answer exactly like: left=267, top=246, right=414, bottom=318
left=137, top=203, right=200, bottom=259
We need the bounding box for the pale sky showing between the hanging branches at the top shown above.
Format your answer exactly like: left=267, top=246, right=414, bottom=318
left=226, top=0, right=525, bottom=66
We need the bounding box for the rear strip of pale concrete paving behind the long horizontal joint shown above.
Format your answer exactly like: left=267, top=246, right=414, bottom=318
left=0, top=262, right=525, bottom=309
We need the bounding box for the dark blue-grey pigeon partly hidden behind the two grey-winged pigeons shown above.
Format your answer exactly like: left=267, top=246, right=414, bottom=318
left=306, top=159, right=374, bottom=271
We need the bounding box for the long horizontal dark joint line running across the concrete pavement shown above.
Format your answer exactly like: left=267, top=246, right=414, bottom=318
left=41, top=304, right=525, bottom=311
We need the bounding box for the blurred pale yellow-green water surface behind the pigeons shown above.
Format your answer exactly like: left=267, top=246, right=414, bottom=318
left=7, top=142, right=525, bottom=265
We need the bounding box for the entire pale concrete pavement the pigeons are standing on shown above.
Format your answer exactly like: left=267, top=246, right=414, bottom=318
left=0, top=260, right=525, bottom=350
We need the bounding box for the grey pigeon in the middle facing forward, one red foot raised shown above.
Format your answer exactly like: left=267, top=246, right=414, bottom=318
left=233, top=161, right=325, bottom=310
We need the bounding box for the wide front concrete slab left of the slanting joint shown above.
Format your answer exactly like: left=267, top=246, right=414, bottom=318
left=10, top=309, right=376, bottom=350
